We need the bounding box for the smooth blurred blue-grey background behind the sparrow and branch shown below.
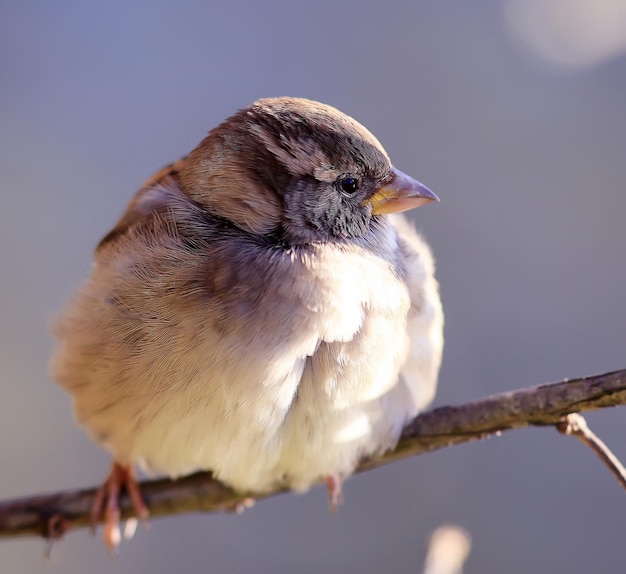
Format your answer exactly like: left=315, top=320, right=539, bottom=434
left=0, top=0, right=626, bottom=574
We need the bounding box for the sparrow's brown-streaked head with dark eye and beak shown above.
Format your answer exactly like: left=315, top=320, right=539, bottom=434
left=180, top=98, right=437, bottom=244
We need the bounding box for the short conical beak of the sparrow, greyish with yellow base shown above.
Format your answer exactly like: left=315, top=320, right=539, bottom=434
left=365, top=168, right=439, bottom=215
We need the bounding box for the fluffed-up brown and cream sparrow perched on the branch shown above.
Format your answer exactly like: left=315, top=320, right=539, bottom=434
left=50, top=97, right=443, bottom=548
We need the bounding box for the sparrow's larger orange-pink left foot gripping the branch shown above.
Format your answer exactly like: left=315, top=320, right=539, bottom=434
left=91, top=462, right=150, bottom=552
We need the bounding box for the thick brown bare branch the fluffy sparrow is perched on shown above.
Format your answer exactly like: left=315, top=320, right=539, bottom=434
left=0, top=369, right=626, bottom=538
